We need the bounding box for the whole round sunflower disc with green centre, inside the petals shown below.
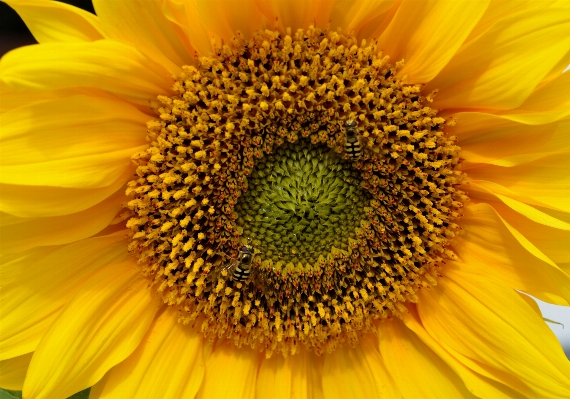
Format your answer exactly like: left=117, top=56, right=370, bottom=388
left=125, top=26, right=468, bottom=356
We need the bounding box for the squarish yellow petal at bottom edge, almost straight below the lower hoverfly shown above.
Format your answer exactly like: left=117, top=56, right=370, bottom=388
left=196, top=340, right=263, bottom=399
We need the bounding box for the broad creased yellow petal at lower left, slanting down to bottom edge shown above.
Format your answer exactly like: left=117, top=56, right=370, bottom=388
left=23, top=260, right=159, bottom=399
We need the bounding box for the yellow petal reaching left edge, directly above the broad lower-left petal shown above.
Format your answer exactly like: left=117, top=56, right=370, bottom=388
left=0, top=233, right=127, bottom=359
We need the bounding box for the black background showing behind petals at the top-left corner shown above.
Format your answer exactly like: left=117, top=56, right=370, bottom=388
left=0, top=0, right=95, bottom=57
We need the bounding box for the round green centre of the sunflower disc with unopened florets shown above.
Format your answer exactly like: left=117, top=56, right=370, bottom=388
left=236, top=142, right=369, bottom=264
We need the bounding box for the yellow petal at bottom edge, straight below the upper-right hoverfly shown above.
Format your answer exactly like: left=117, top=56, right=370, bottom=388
left=323, top=337, right=396, bottom=399
